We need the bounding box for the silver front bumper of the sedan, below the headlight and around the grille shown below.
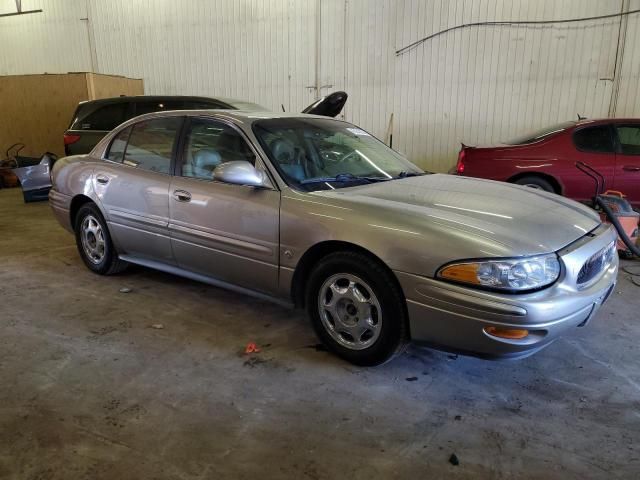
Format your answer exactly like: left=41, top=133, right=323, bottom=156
left=396, top=226, right=618, bottom=357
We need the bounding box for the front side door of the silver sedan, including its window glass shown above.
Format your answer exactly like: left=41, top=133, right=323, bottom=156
left=169, top=118, right=280, bottom=293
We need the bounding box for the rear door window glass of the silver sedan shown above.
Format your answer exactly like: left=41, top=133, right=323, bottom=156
left=123, top=117, right=182, bottom=174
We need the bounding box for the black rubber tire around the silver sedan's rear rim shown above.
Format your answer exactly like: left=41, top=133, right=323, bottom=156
left=74, top=203, right=128, bottom=275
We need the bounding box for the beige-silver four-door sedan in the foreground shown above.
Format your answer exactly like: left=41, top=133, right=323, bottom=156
left=49, top=110, right=618, bottom=365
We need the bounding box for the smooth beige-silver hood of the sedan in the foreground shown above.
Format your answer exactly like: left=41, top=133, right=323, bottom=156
left=316, top=174, right=600, bottom=257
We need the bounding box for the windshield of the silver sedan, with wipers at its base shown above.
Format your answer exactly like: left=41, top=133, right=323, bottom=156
left=253, top=117, right=425, bottom=191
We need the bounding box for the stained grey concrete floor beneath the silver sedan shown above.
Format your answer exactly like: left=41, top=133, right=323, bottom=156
left=0, top=189, right=640, bottom=480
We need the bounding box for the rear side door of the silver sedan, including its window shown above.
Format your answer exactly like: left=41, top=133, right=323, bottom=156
left=93, top=117, right=183, bottom=263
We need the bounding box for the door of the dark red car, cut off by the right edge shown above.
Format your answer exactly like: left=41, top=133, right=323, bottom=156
left=613, top=124, right=640, bottom=208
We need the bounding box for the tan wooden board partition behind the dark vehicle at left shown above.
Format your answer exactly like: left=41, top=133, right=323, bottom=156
left=0, top=72, right=144, bottom=159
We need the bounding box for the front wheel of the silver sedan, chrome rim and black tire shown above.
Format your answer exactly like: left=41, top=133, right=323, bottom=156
left=306, top=252, right=408, bottom=366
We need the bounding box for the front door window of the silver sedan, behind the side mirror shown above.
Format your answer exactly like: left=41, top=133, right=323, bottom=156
left=182, top=118, right=256, bottom=180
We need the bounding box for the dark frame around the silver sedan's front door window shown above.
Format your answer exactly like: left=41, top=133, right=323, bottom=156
left=172, top=115, right=279, bottom=191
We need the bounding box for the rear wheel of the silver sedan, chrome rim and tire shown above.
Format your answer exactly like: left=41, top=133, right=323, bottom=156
left=75, top=203, right=127, bottom=275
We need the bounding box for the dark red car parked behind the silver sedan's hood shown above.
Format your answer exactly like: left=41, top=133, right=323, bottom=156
left=456, top=118, right=640, bottom=209
